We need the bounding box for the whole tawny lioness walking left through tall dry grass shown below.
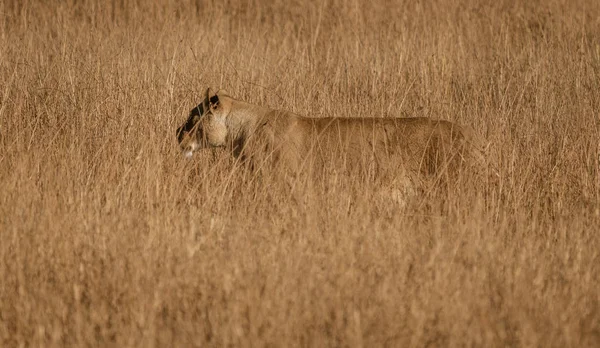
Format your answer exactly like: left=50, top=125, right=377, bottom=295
left=177, top=88, right=492, bottom=200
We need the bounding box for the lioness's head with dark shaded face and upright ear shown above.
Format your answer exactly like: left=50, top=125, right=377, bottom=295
left=177, top=88, right=231, bottom=157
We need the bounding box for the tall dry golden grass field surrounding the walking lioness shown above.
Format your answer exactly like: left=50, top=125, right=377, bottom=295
left=0, top=0, right=600, bottom=347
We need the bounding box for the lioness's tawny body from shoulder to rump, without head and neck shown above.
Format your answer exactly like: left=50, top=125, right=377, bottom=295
left=246, top=110, right=484, bottom=181
